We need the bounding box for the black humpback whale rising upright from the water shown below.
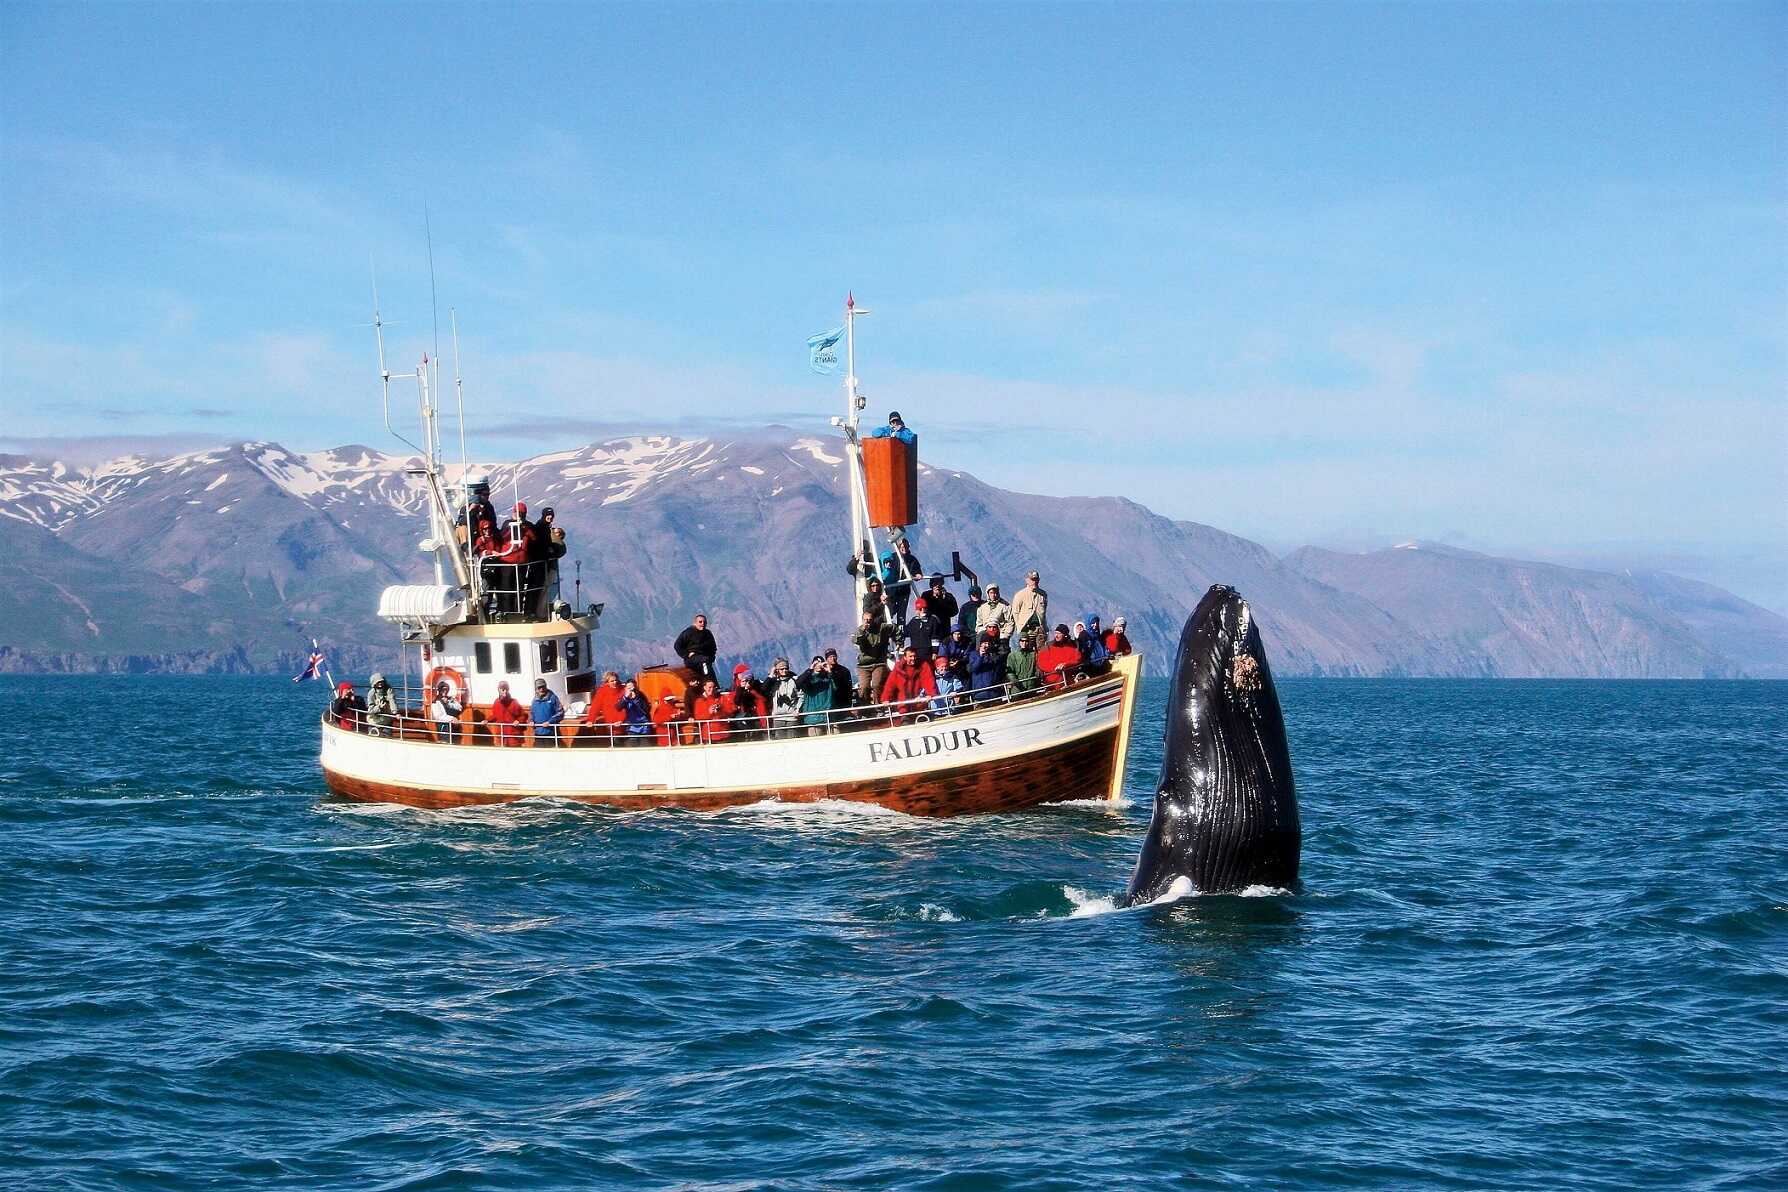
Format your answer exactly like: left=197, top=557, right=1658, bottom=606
left=1123, top=584, right=1303, bottom=906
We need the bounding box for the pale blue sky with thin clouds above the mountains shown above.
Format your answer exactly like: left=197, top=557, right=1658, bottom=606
left=0, top=4, right=1788, bottom=609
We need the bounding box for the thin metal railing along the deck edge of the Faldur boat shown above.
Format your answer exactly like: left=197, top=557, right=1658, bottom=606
left=324, top=665, right=1118, bottom=749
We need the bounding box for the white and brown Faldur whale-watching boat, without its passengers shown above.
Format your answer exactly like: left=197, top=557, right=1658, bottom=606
left=320, top=298, right=1141, bottom=817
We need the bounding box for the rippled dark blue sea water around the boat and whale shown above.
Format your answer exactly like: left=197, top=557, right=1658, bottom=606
left=0, top=677, right=1788, bottom=1188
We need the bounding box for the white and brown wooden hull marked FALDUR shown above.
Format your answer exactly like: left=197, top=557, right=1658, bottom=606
left=322, top=658, right=1141, bottom=817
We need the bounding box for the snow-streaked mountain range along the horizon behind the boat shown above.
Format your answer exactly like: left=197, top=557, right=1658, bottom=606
left=0, top=431, right=1788, bottom=677
